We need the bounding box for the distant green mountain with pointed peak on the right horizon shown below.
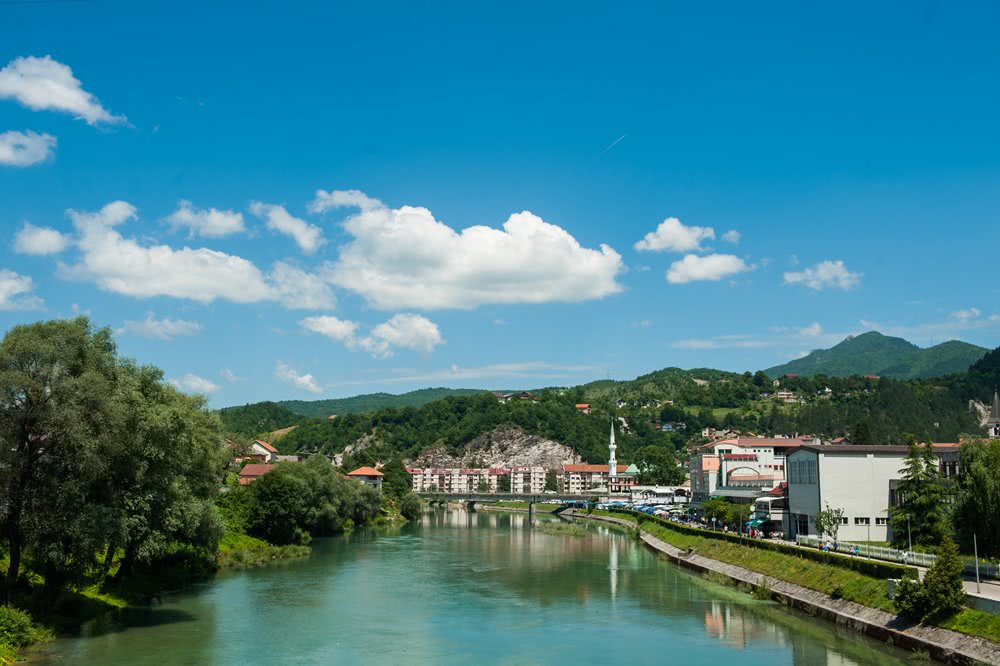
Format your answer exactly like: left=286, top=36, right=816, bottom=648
left=764, top=331, right=987, bottom=379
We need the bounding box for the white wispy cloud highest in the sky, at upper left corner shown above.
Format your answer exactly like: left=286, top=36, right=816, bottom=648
left=0, top=56, right=126, bottom=125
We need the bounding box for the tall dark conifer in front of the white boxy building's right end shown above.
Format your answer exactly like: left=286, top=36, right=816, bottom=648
left=889, top=443, right=950, bottom=548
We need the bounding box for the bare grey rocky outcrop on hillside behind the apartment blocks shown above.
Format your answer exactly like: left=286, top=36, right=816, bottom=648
left=408, top=427, right=581, bottom=469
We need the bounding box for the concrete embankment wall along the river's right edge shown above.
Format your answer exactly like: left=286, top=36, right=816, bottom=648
left=563, top=510, right=1000, bottom=665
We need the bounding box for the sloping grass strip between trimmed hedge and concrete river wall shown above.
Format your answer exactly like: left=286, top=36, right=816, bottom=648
left=593, top=511, right=1000, bottom=642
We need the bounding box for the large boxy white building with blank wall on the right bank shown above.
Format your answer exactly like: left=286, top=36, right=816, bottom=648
left=786, top=444, right=959, bottom=541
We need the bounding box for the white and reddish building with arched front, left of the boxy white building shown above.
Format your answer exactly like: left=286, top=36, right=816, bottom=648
left=690, top=437, right=804, bottom=503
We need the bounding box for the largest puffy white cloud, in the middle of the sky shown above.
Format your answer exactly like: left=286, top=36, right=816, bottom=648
left=312, top=191, right=623, bottom=310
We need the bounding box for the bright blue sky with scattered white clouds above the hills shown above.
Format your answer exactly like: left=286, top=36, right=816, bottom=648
left=0, top=0, right=1000, bottom=407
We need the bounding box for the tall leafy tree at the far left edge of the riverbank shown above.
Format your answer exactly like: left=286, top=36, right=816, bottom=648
left=0, top=317, right=115, bottom=603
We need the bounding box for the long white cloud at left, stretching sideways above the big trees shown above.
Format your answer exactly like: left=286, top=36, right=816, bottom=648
left=60, top=201, right=334, bottom=309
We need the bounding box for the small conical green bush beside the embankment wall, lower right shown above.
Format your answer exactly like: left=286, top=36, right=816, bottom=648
left=893, top=537, right=965, bottom=620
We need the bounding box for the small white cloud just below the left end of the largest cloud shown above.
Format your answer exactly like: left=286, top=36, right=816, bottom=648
left=299, top=314, right=444, bottom=358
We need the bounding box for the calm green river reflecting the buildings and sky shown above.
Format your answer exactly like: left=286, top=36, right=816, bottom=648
left=33, top=511, right=907, bottom=666
